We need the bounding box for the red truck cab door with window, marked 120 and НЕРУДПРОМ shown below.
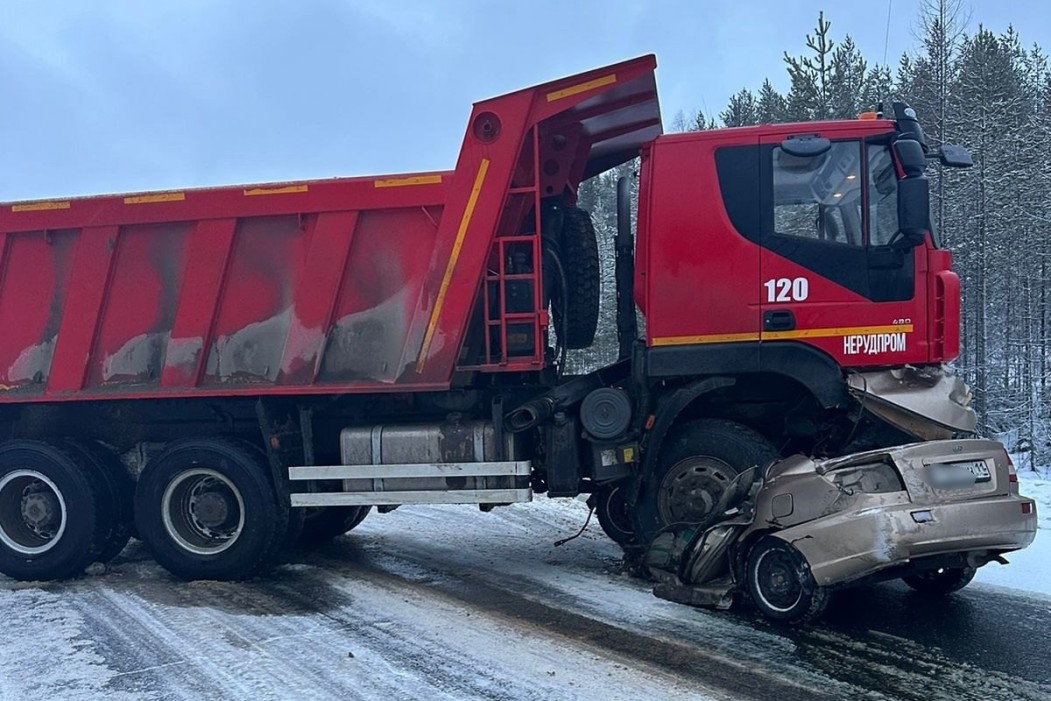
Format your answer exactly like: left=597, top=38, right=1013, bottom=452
left=760, top=133, right=927, bottom=367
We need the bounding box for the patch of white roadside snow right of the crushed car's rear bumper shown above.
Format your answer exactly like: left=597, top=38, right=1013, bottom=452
left=974, top=470, right=1051, bottom=596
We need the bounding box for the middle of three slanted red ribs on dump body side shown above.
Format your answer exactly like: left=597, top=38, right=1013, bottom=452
left=161, top=219, right=238, bottom=388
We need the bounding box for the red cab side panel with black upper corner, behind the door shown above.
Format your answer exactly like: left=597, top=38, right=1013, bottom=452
left=639, top=132, right=761, bottom=357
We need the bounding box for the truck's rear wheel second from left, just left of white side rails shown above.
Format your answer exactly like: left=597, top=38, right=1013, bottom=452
left=135, top=438, right=288, bottom=579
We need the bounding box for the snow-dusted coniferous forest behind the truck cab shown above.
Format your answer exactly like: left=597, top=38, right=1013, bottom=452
left=571, top=0, right=1051, bottom=465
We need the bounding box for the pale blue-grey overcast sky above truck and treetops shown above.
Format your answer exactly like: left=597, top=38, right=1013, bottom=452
left=0, top=0, right=1051, bottom=201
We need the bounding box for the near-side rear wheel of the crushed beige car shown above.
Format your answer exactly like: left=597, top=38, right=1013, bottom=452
left=745, top=536, right=828, bottom=623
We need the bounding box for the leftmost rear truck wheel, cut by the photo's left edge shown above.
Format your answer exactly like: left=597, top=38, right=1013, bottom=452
left=0, top=440, right=114, bottom=580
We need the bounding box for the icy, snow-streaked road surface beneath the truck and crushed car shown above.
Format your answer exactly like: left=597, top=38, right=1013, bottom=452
left=0, top=498, right=1051, bottom=701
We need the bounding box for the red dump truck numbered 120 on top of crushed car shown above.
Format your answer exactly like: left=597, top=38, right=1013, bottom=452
left=0, top=56, right=974, bottom=579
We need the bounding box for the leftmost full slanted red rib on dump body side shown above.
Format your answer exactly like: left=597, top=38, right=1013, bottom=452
left=47, top=226, right=120, bottom=394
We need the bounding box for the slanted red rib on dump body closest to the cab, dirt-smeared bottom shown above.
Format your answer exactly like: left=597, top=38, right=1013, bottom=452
left=277, top=211, right=357, bottom=385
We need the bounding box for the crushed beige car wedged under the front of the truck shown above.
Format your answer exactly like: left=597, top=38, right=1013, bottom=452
left=645, top=439, right=1036, bottom=623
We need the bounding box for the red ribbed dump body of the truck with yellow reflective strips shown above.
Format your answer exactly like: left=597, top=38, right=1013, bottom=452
left=0, top=57, right=660, bottom=403
